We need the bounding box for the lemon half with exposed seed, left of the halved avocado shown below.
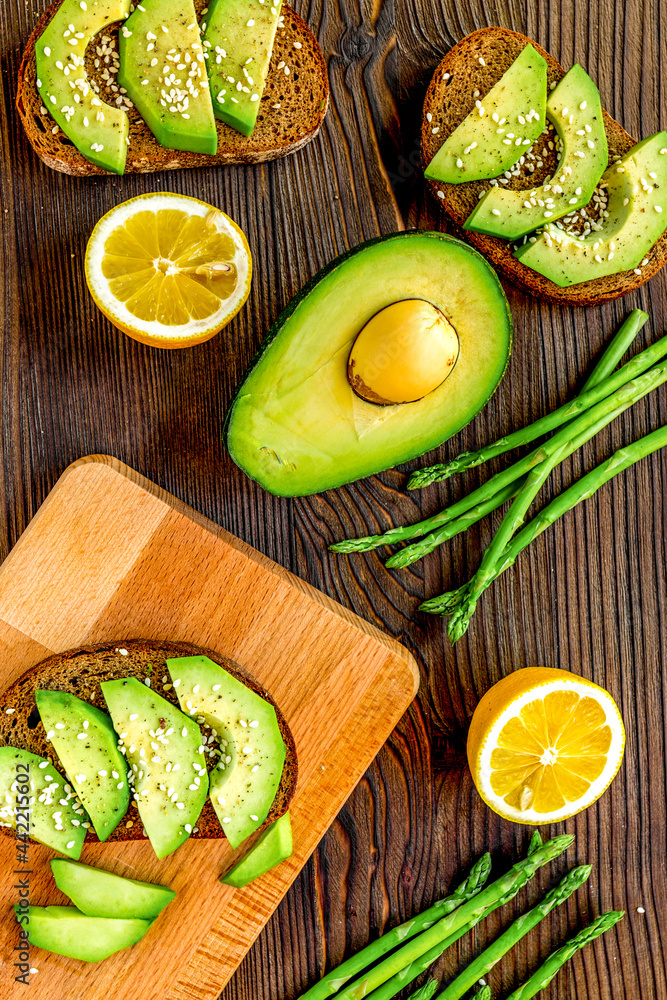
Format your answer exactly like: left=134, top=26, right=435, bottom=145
left=85, top=193, right=252, bottom=348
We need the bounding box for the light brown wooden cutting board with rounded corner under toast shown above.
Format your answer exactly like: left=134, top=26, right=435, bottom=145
left=0, top=456, right=418, bottom=1000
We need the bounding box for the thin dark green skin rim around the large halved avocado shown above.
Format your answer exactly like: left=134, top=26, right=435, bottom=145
left=222, top=229, right=513, bottom=496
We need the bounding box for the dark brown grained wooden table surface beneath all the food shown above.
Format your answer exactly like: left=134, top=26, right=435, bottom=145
left=0, top=0, right=667, bottom=1000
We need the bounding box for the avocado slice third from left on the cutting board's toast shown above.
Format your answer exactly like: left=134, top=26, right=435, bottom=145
left=101, top=677, right=208, bottom=858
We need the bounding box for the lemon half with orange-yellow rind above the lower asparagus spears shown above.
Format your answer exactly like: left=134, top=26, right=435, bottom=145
left=468, top=667, right=625, bottom=826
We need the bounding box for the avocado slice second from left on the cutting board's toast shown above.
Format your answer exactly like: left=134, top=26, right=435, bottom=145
left=35, top=691, right=130, bottom=841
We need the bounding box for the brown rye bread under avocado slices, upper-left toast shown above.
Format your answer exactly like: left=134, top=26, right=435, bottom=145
left=16, top=0, right=329, bottom=177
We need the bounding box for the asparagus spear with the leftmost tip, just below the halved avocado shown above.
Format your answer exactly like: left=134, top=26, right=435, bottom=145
left=329, top=362, right=667, bottom=564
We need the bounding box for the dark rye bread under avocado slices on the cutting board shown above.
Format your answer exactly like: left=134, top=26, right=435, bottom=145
left=0, top=639, right=298, bottom=843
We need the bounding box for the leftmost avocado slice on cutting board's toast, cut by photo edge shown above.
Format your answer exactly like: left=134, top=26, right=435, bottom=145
left=0, top=747, right=90, bottom=860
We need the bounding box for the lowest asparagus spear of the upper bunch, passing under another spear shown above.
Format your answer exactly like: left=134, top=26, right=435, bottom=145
left=419, top=425, right=667, bottom=615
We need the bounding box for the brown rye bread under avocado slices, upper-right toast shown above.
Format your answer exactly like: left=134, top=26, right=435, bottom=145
left=421, top=28, right=667, bottom=306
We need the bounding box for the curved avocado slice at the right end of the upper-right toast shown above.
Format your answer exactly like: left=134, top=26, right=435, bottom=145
left=514, top=132, right=667, bottom=288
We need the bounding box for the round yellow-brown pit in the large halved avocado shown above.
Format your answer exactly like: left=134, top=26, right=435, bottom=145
left=347, top=299, right=459, bottom=406
